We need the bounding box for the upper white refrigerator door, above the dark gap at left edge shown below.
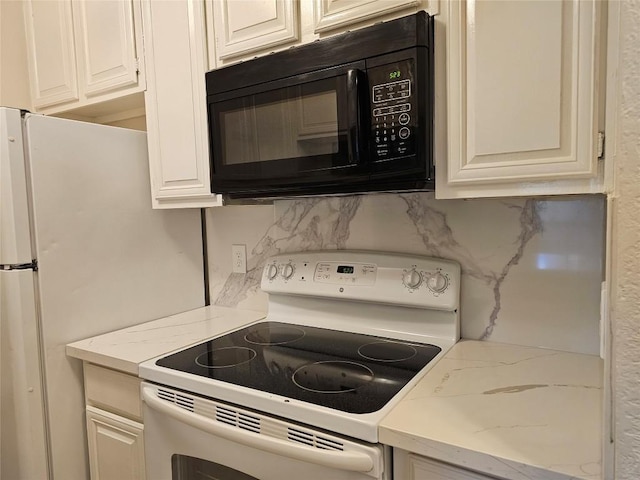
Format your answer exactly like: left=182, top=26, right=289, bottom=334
left=0, top=108, right=32, bottom=268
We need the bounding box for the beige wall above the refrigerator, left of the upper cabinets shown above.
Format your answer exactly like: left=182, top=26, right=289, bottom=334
left=0, top=0, right=31, bottom=110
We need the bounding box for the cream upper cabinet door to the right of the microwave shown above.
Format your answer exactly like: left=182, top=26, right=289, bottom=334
left=436, top=0, right=602, bottom=198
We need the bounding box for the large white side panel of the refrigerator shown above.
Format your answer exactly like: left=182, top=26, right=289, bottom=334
left=25, top=115, right=204, bottom=479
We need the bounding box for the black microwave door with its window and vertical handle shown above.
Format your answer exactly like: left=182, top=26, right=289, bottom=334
left=207, top=61, right=369, bottom=196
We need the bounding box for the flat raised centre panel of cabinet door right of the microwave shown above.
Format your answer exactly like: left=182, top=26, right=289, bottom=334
left=467, top=1, right=570, bottom=156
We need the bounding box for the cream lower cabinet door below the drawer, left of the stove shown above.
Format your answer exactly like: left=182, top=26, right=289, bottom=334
left=87, top=406, right=145, bottom=480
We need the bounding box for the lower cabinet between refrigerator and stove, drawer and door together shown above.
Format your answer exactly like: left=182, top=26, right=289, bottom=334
left=84, top=363, right=146, bottom=480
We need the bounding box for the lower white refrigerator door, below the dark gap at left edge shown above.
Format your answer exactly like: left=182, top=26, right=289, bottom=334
left=0, top=270, right=47, bottom=480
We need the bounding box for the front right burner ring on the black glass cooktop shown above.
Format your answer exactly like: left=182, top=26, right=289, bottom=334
left=291, top=360, right=373, bottom=393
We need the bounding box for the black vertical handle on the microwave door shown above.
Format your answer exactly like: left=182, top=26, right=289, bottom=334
left=347, top=68, right=367, bottom=165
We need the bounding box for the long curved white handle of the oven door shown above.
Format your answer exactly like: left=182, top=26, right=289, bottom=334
left=142, top=387, right=374, bottom=472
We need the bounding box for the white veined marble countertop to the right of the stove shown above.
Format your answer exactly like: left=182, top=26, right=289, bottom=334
left=379, top=340, right=603, bottom=480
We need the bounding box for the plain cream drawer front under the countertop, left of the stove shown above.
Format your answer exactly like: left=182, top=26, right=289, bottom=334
left=84, top=363, right=142, bottom=420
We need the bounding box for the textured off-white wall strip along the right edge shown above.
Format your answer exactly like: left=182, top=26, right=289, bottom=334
left=612, top=1, right=640, bottom=480
